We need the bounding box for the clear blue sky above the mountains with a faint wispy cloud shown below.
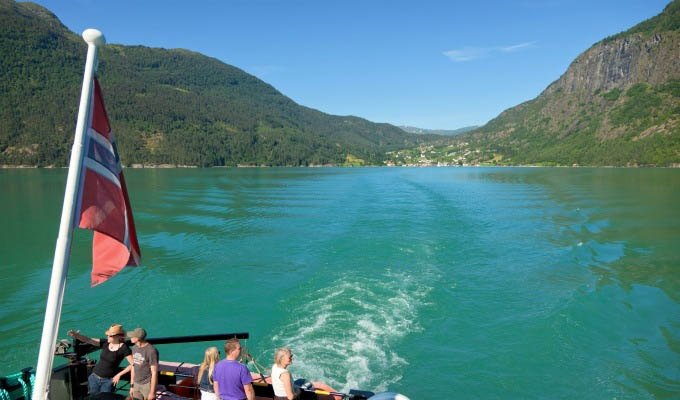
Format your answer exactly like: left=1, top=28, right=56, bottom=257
left=30, top=0, right=668, bottom=129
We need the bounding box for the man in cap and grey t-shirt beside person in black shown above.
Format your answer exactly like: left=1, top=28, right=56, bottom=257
left=128, top=328, right=158, bottom=400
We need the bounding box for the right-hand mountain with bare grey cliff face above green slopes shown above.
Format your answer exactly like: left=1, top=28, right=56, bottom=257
left=392, top=0, right=680, bottom=166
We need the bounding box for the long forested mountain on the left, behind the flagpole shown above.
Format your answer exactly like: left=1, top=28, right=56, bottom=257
left=0, top=0, right=433, bottom=166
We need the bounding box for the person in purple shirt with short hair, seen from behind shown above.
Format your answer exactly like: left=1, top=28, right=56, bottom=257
left=213, top=338, right=255, bottom=400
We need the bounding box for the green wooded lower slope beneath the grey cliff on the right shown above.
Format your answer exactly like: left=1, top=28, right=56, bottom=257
left=461, top=79, right=680, bottom=166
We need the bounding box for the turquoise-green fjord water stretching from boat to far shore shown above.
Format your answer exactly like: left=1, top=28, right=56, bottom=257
left=0, top=168, right=680, bottom=399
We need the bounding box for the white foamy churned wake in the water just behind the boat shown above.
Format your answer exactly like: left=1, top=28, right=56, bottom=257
left=272, top=270, right=432, bottom=391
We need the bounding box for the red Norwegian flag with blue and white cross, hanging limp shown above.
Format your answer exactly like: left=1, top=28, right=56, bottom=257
left=74, top=78, right=141, bottom=286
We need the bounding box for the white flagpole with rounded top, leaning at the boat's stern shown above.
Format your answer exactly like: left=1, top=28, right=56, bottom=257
left=32, top=29, right=106, bottom=400
